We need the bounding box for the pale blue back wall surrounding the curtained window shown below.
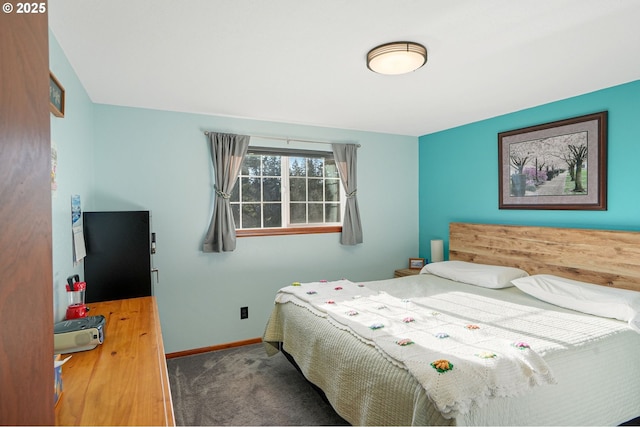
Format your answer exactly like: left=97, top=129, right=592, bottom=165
left=88, top=106, right=418, bottom=352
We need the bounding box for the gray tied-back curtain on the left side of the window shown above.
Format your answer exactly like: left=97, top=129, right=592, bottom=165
left=202, top=132, right=249, bottom=252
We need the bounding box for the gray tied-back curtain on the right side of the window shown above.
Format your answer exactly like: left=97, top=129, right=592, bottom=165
left=331, top=144, right=362, bottom=245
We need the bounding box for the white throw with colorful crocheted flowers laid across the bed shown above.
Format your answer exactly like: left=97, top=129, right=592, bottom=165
left=278, top=280, right=555, bottom=418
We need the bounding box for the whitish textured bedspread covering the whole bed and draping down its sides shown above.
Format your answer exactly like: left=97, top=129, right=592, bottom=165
left=264, top=275, right=640, bottom=425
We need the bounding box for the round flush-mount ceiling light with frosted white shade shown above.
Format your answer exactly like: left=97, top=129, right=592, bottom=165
left=367, top=42, right=427, bottom=74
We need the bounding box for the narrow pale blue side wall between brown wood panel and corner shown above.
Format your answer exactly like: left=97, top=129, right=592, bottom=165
left=49, top=32, right=94, bottom=321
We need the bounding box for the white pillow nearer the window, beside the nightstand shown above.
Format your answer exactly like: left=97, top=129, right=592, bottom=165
left=420, top=261, right=529, bottom=289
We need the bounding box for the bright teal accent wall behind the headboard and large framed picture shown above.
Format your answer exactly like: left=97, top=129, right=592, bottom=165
left=419, top=81, right=640, bottom=257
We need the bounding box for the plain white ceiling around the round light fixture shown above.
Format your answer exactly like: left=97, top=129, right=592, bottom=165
left=49, top=0, right=640, bottom=136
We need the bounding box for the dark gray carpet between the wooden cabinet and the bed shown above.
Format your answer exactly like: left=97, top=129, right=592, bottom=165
left=167, top=344, right=348, bottom=426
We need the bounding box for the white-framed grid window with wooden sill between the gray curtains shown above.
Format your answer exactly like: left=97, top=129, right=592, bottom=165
left=230, top=147, right=345, bottom=236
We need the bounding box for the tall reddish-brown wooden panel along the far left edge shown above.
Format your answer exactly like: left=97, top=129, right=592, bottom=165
left=0, top=1, right=54, bottom=425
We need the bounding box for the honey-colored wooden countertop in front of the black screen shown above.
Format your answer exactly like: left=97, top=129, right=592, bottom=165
left=55, top=297, right=175, bottom=426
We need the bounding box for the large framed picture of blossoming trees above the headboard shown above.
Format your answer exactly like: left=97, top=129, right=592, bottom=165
left=498, top=111, right=607, bottom=210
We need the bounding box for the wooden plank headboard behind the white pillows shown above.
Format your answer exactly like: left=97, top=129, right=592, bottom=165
left=449, top=222, right=640, bottom=291
